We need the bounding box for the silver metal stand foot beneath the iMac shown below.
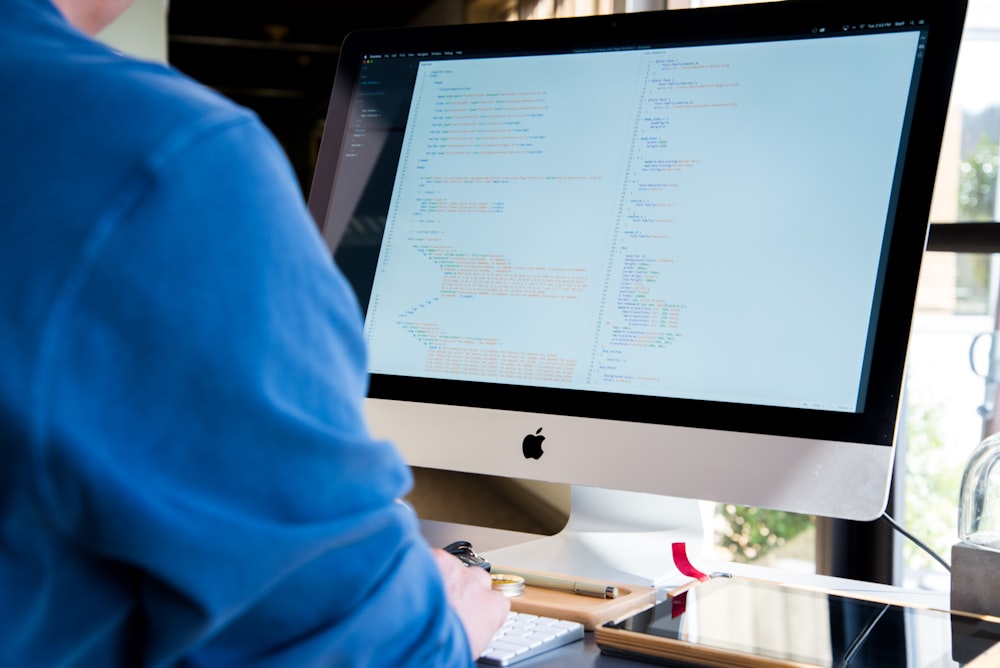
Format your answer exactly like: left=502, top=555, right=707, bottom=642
left=484, top=485, right=710, bottom=586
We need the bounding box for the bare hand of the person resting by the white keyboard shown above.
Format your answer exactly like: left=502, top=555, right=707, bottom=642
left=434, top=549, right=510, bottom=659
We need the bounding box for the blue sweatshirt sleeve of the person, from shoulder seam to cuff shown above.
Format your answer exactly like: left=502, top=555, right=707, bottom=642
left=35, top=115, right=470, bottom=666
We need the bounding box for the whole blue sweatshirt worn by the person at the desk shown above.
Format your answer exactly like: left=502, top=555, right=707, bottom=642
left=0, top=0, right=470, bottom=668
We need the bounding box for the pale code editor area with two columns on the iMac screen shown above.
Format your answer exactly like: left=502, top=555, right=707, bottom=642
left=366, top=32, right=918, bottom=411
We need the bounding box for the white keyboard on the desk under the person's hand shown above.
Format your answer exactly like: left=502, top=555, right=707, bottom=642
left=479, top=612, right=583, bottom=666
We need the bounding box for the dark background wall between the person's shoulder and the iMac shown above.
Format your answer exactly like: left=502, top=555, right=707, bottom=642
left=168, top=0, right=442, bottom=194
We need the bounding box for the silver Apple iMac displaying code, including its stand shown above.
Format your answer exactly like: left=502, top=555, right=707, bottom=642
left=309, top=0, right=965, bottom=582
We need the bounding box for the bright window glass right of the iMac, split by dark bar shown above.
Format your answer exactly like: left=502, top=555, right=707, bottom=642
left=897, top=0, right=1000, bottom=590
